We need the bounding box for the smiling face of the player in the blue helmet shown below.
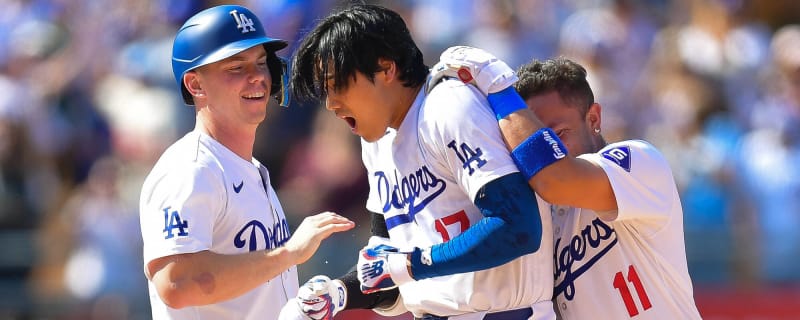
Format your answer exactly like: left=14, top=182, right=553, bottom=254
left=197, top=46, right=272, bottom=125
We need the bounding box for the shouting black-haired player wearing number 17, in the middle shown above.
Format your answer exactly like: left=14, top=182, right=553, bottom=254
left=281, top=5, right=555, bottom=320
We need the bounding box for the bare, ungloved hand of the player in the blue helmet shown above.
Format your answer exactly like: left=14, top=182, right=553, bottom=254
left=284, top=212, right=355, bottom=264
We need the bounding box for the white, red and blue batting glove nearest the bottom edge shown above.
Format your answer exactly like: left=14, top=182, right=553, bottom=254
left=296, top=275, right=347, bottom=320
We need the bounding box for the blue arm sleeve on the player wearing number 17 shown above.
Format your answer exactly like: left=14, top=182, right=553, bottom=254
left=411, top=173, right=542, bottom=280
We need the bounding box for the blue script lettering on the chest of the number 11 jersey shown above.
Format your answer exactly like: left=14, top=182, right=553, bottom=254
left=553, top=218, right=617, bottom=300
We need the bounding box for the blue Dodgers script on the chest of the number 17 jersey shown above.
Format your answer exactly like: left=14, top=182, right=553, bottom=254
left=374, top=166, right=446, bottom=226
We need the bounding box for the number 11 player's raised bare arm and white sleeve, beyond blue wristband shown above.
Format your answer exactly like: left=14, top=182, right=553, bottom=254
left=529, top=136, right=675, bottom=221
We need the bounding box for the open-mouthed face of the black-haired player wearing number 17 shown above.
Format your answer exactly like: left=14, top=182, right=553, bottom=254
left=325, top=72, right=393, bottom=142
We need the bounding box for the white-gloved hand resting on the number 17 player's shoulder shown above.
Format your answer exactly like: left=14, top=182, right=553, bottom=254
left=428, top=46, right=518, bottom=95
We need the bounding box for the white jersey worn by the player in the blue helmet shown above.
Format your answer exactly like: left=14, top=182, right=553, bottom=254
left=140, top=131, right=299, bottom=320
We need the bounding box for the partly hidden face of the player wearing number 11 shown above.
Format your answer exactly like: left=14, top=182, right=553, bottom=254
left=525, top=91, right=595, bottom=157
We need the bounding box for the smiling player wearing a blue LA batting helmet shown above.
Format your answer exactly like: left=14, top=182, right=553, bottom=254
left=140, top=5, right=353, bottom=319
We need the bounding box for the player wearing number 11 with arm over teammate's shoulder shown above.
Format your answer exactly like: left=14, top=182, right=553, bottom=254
left=431, top=47, right=700, bottom=319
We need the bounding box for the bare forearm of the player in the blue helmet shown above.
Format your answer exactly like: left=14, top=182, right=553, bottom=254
left=152, top=248, right=294, bottom=309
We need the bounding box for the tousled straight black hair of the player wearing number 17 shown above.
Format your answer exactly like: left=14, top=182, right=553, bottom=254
left=291, top=4, right=428, bottom=101
